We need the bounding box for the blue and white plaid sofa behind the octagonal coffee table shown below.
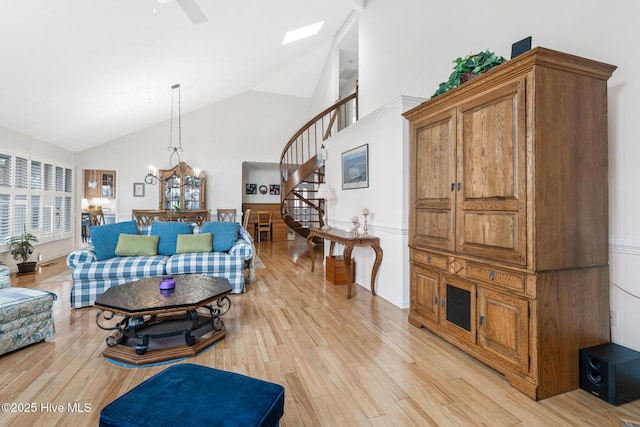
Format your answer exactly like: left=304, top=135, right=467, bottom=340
left=67, top=221, right=255, bottom=308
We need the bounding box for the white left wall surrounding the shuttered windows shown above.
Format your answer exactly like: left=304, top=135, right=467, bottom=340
left=0, top=126, right=76, bottom=271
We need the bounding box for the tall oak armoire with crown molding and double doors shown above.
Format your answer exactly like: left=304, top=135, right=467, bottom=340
left=404, top=47, right=616, bottom=400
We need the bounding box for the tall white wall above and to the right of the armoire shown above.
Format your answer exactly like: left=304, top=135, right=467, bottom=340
left=315, top=0, right=640, bottom=350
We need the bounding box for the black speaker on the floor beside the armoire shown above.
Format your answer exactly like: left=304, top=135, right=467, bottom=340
left=580, top=343, right=640, bottom=405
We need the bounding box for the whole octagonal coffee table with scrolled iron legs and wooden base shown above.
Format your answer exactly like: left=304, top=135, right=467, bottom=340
left=95, top=274, right=231, bottom=365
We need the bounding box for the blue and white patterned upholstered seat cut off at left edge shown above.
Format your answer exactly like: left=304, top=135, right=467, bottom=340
left=0, top=265, right=57, bottom=355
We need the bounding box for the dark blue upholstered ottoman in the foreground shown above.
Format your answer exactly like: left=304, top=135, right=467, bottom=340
left=100, top=363, right=284, bottom=427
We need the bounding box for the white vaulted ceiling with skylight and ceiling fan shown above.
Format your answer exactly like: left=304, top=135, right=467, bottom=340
left=0, top=0, right=364, bottom=152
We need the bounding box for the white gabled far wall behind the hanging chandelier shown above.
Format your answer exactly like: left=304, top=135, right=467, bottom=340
left=77, top=92, right=315, bottom=224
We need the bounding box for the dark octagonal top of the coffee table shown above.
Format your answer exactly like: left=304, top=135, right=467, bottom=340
left=95, top=274, right=231, bottom=315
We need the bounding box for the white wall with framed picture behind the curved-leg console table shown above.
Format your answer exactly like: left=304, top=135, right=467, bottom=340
left=325, top=97, right=422, bottom=308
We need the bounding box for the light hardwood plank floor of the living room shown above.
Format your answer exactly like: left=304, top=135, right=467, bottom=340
left=0, top=239, right=640, bottom=427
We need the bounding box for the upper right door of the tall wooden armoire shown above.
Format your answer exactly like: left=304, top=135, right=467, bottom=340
left=456, top=77, right=527, bottom=265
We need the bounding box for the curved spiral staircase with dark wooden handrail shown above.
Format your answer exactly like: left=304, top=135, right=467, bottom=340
left=280, top=83, right=358, bottom=237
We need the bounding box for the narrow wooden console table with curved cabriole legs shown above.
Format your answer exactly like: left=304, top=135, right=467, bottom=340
left=307, top=228, right=382, bottom=298
